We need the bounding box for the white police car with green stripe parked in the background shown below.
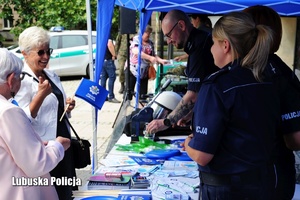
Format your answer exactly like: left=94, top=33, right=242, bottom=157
left=10, top=30, right=96, bottom=77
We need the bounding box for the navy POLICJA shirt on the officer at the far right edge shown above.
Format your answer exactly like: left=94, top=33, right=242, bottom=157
left=265, top=54, right=300, bottom=166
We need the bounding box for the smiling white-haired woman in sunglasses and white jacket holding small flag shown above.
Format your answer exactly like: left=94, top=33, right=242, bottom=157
left=15, top=26, right=76, bottom=200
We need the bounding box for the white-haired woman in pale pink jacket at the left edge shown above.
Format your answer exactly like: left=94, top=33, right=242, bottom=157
left=0, top=49, right=70, bottom=200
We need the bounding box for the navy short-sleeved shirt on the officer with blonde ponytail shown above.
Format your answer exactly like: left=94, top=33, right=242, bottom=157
left=189, top=63, right=280, bottom=174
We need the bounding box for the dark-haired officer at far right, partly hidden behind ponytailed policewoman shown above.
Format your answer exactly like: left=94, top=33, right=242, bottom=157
left=244, top=5, right=300, bottom=200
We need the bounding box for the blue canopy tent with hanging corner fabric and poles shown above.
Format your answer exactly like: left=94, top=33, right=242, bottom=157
left=93, top=0, right=300, bottom=171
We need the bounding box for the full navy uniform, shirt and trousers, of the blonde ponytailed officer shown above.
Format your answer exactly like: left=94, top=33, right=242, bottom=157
left=189, top=62, right=280, bottom=200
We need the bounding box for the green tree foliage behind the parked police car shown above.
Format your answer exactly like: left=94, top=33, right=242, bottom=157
left=0, top=0, right=119, bottom=38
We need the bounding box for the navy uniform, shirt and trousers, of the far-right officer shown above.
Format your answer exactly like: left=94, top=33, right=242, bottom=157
left=266, top=54, right=300, bottom=200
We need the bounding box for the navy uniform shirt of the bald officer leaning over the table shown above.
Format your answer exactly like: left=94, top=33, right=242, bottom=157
left=184, top=28, right=219, bottom=92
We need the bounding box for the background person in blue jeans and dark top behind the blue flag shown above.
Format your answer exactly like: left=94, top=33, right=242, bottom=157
left=100, top=34, right=120, bottom=103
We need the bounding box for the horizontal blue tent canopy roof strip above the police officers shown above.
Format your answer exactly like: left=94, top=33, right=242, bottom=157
left=115, top=0, right=300, bottom=16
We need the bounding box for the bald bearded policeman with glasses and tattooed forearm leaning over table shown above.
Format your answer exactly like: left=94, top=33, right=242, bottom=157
left=147, top=10, right=218, bottom=133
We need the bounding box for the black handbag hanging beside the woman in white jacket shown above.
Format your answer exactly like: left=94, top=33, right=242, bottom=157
left=65, top=117, right=91, bottom=169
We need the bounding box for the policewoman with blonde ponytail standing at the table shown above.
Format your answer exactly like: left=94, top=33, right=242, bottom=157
left=184, top=12, right=280, bottom=200
